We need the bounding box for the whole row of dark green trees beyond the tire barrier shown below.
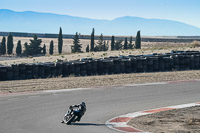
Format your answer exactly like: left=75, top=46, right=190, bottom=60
left=0, top=27, right=141, bottom=55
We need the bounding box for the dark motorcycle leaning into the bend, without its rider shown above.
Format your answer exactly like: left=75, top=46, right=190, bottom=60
left=61, top=107, right=81, bottom=125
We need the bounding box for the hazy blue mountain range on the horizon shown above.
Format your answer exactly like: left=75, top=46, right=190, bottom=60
left=0, top=9, right=200, bottom=36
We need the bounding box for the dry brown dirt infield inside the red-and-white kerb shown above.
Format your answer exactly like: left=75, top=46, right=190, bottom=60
left=128, top=106, right=200, bottom=133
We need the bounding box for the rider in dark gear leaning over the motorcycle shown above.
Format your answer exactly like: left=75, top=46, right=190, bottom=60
left=61, top=102, right=86, bottom=123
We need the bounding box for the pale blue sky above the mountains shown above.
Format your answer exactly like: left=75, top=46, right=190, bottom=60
left=0, top=0, right=200, bottom=28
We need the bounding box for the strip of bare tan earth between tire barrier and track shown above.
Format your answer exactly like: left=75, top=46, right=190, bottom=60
left=0, top=71, right=200, bottom=93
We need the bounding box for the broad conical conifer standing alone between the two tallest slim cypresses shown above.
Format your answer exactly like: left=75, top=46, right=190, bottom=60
left=71, top=32, right=82, bottom=53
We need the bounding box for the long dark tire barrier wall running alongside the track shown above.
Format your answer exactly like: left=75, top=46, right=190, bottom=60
left=0, top=51, right=200, bottom=81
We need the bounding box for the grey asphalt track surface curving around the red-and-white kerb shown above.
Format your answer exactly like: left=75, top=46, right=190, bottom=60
left=0, top=81, right=200, bottom=133
